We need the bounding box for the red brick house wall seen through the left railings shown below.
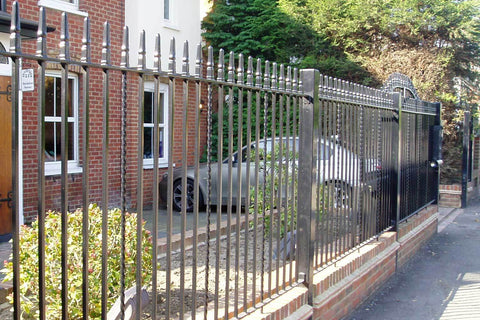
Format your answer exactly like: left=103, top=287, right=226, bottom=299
left=7, top=0, right=206, bottom=223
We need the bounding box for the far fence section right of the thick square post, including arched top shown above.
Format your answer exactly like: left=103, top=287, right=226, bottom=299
left=297, top=70, right=441, bottom=296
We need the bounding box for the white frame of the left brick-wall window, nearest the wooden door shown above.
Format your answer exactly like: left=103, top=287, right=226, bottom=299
left=45, top=71, right=82, bottom=176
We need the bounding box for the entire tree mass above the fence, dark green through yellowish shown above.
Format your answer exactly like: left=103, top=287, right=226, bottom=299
left=203, top=0, right=480, bottom=183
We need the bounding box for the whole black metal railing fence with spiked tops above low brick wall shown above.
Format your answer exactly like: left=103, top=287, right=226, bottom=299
left=0, top=6, right=439, bottom=319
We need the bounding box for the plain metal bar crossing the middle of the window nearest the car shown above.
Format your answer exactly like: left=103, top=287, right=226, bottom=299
left=152, top=33, right=163, bottom=320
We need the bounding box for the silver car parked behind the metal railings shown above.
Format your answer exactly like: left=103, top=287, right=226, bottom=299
left=159, top=138, right=378, bottom=212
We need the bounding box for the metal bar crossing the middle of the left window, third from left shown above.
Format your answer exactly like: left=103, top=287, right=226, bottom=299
left=59, top=12, right=70, bottom=319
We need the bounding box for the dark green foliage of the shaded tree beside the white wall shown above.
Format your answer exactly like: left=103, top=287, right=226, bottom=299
left=202, top=0, right=372, bottom=84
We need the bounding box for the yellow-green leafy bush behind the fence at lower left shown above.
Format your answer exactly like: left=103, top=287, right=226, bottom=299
left=1, top=204, right=152, bottom=319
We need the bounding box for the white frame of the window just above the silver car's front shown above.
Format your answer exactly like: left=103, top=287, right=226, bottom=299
left=143, top=82, right=169, bottom=169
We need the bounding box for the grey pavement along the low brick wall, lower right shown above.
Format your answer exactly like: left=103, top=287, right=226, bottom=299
left=344, top=204, right=480, bottom=320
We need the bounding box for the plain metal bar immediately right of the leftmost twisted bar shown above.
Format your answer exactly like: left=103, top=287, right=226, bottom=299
left=135, top=30, right=145, bottom=320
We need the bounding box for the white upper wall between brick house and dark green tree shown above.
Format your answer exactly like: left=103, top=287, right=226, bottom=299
left=125, top=0, right=208, bottom=73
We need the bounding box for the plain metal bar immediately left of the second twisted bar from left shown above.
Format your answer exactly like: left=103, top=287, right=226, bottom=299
left=192, top=44, right=203, bottom=320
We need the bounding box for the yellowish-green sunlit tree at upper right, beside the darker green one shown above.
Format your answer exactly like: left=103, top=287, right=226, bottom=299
left=288, top=0, right=480, bottom=183
